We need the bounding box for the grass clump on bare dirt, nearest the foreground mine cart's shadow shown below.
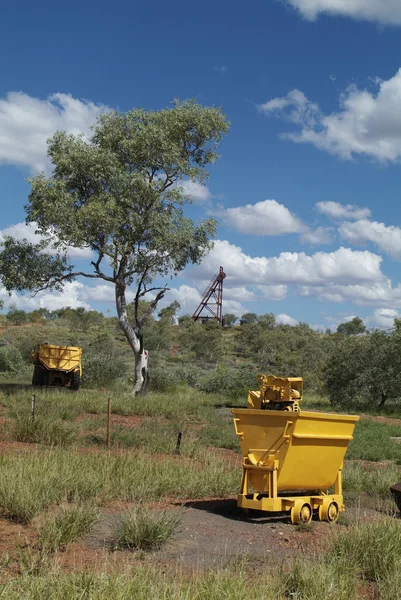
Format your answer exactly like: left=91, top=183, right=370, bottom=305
left=115, top=506, right=182, bottom=552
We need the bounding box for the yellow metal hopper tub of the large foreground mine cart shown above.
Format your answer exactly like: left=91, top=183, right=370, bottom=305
left=232, top=408, right=359, bottom=493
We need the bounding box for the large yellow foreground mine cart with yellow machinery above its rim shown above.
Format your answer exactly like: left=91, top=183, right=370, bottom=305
left=232, top=375, right=359, bottom=524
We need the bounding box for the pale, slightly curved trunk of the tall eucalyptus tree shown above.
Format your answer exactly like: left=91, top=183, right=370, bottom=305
left=116, top=281, right=149, bottom=396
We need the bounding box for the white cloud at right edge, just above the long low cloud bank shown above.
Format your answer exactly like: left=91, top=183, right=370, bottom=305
left=338, top=219, right=401, bottom=259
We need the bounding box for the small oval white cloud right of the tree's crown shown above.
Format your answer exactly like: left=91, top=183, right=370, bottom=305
left=215, top=200, right=307, bottom=235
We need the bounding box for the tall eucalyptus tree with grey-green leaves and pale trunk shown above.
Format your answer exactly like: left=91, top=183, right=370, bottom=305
left=0, top=100, right=228, bottom=393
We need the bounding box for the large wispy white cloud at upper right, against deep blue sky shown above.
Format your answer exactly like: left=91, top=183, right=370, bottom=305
left=258, top=69, right=401, bottom=162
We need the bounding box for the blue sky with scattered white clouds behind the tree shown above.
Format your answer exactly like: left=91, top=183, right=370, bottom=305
left=0, top=0, right=401, bottom=328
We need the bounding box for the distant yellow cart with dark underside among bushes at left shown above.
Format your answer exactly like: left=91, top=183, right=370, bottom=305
left=32, top=344, right=82, bottom=390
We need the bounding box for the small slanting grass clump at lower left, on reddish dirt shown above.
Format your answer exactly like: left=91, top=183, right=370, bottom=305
left=39, top=504, right=99, bottom=553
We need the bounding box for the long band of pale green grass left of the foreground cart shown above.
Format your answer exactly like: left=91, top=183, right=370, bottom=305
left=0, top=449, right=241, bottom=523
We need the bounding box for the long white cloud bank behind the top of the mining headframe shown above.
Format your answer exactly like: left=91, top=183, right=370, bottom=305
left=194, top=240, right=384, bottom=286
